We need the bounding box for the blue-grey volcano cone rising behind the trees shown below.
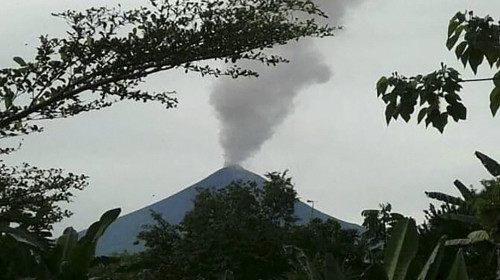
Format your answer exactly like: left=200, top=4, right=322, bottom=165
left=96, top=166, right=361, bottom=256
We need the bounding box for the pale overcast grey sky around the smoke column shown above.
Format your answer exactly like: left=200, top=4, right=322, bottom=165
left=0, top=0, right=500, bottom=233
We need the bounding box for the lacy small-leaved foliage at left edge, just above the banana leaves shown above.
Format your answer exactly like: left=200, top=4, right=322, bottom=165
left=0, top=164, right=86, bottom=232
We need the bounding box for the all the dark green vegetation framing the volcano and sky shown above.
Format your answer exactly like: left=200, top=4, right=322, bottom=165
left=0, top=3, right=500, bottom=280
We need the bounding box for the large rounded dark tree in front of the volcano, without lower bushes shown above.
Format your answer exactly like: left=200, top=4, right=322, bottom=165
left=139, top=175, right=296, bottom=280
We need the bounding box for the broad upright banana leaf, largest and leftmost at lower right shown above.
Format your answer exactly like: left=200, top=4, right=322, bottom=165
left=384, top=218, right=418, bottom=280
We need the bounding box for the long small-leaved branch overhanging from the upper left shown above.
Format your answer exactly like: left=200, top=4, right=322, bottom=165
left=0, top=0, right=333, bottom=137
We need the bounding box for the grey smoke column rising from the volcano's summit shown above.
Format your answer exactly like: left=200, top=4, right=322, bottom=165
left=210, top=0, right=358, bottom=166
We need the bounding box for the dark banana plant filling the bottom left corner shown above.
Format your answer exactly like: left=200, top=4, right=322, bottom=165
left=0, top=208, right=120, bottom=280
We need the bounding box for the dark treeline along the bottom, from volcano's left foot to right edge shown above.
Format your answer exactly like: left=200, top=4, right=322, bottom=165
left=93, top=152, right=500, bottom=280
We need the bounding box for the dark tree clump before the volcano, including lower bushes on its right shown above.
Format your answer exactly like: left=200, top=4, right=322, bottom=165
left=133, top=173, right=362, bottom=280
